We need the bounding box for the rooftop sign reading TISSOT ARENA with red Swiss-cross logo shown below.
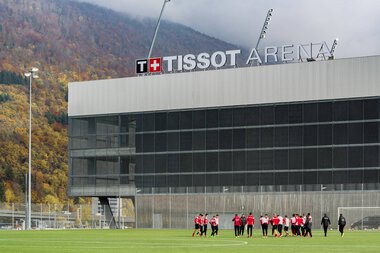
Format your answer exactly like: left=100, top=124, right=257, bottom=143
left=136, top=42, right=333, bottom=74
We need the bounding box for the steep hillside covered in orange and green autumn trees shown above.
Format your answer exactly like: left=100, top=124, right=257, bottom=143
left=0, top=0, right=242, bottom=206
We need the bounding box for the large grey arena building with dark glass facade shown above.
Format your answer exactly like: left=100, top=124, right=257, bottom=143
left=69, top=56, right=380, bottom=228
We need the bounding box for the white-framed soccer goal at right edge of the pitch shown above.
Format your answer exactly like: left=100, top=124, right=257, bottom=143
left=338, top=207, right=380, bottom=230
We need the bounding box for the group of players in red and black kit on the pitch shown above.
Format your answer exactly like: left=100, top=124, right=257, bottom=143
left=192, top=213, right=345, bottom=238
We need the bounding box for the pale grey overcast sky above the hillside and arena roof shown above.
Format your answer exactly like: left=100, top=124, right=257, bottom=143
left=79, top=0, right=380, bottom=58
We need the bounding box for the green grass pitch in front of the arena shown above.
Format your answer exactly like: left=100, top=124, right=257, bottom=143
left=0, top=229, right=380, bottom=253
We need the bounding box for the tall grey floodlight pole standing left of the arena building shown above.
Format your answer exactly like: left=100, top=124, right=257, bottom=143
left=24, top=68, right=38, bottom=230
